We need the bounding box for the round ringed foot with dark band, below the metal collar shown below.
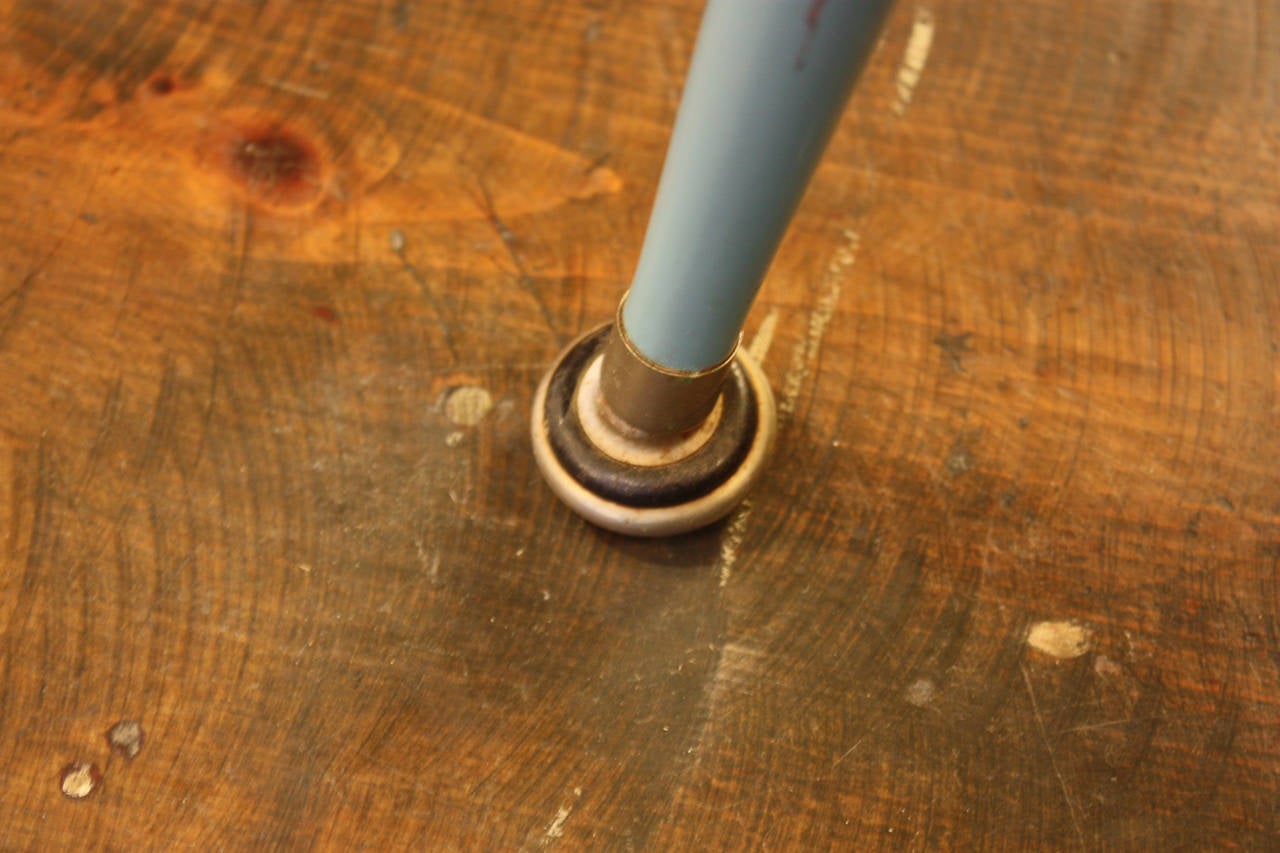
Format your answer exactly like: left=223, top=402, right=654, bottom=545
left=531, top=324, right=777, bottom=537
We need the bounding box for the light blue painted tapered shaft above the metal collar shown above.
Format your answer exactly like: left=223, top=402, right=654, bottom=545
left=622, top=0, right=890, bottom=371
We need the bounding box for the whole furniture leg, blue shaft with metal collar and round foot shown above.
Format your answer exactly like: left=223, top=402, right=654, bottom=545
left=531, top=0, right=890, bottom=535
